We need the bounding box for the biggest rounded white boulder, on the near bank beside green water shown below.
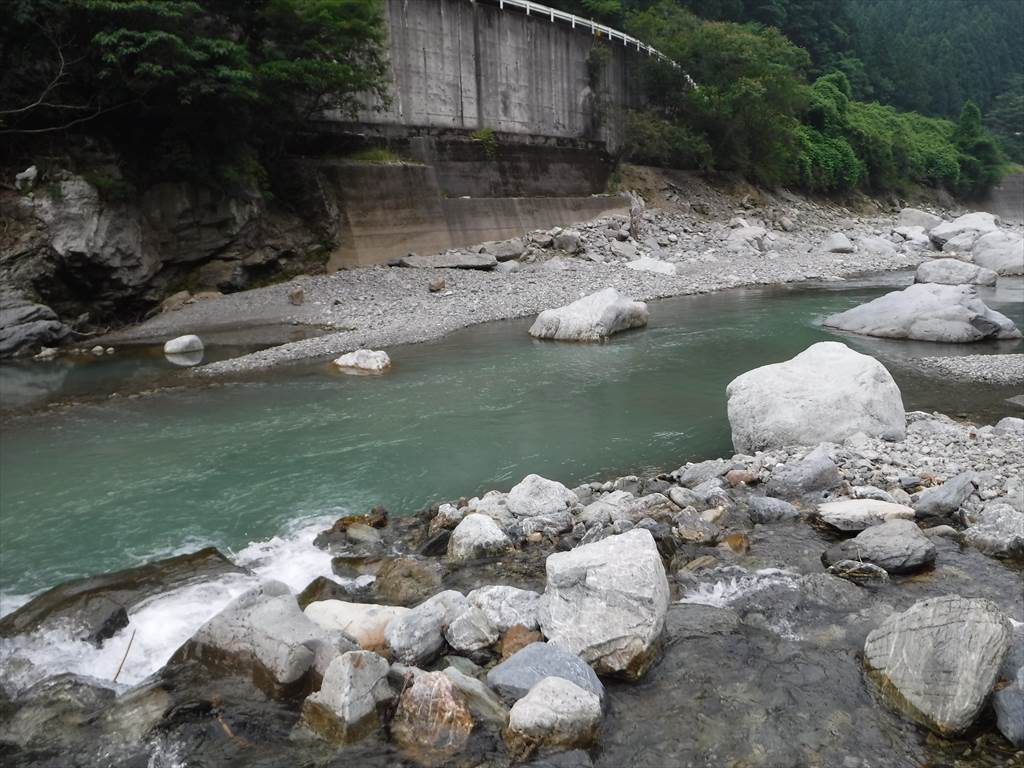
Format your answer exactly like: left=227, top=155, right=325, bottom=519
left=725, top=341, right=906, bottom=454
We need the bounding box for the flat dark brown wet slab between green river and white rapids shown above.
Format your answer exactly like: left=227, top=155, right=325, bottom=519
left=0, top=547, right=245, bottom=644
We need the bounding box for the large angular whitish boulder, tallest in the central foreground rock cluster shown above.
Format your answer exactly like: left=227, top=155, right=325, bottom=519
left=539, top=528, right=669, bottom=679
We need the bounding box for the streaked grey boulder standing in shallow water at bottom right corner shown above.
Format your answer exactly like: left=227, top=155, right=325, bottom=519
left=864, top=598, right=1011, bottom=736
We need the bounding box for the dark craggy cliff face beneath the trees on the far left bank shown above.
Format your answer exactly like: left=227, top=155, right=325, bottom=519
left=0, top=172, right=326, bottom=356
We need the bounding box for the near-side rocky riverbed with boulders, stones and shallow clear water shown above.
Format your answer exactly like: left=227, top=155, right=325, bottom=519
left=0, top=342, right=1024, bottom=768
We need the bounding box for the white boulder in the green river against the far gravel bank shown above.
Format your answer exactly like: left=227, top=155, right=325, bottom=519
left=529, top=288, right=648, bottom=341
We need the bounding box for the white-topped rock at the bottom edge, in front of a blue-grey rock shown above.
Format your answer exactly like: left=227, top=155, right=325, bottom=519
left=506, top=677, right=601, bottom=755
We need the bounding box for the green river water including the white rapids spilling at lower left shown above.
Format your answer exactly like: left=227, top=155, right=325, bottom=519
left=0, top=274, right=1024, bottom=696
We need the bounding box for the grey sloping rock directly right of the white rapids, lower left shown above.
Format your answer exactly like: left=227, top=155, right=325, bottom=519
left=173, top=582, right=354, bottom=696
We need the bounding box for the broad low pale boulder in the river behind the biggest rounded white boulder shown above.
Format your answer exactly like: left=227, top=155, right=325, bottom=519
left=824, top=283, right=1021, bottom=343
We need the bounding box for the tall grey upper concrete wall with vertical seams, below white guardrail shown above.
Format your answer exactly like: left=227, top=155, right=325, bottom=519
left=336, top=0, right=646, bottom=150
